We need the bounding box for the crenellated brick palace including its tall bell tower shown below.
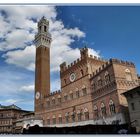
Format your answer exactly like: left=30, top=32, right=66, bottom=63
left=34, top=17, right=139, bottom=127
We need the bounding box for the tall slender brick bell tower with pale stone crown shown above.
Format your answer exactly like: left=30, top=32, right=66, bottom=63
left=34, top=17, right=52, bottom=114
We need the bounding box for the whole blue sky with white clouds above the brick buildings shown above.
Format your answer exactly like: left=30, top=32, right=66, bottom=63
left=0, top=5, right=140, bottom=110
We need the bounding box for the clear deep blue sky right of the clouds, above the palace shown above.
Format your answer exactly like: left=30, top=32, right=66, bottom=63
left=58, top=6, right=140, bottom=73
